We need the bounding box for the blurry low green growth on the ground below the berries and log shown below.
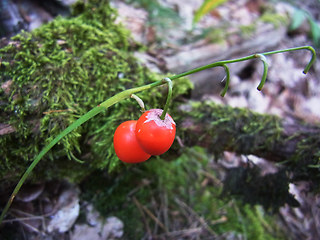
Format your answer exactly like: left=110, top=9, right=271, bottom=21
left=82, top=147, right=285, bottom=240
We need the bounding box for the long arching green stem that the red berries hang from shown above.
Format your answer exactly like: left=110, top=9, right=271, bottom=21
left=0, top=46, right=316, bottom=224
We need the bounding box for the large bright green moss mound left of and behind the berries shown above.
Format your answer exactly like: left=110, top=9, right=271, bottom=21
left=0, top=0, right=191, bottom=181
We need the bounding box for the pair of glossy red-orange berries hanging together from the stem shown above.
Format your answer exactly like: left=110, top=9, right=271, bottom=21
left=113, top=109, right=176, bottom=163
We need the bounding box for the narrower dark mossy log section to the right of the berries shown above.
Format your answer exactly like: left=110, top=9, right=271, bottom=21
left=176, top=102, right=320, bottom=187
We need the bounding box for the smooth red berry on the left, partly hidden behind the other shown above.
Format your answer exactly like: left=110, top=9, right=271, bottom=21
left=113, top=120, right=151, bottom=163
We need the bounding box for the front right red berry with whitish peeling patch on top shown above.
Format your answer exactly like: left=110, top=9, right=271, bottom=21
left=136, top=109, right=176, bottom=155
